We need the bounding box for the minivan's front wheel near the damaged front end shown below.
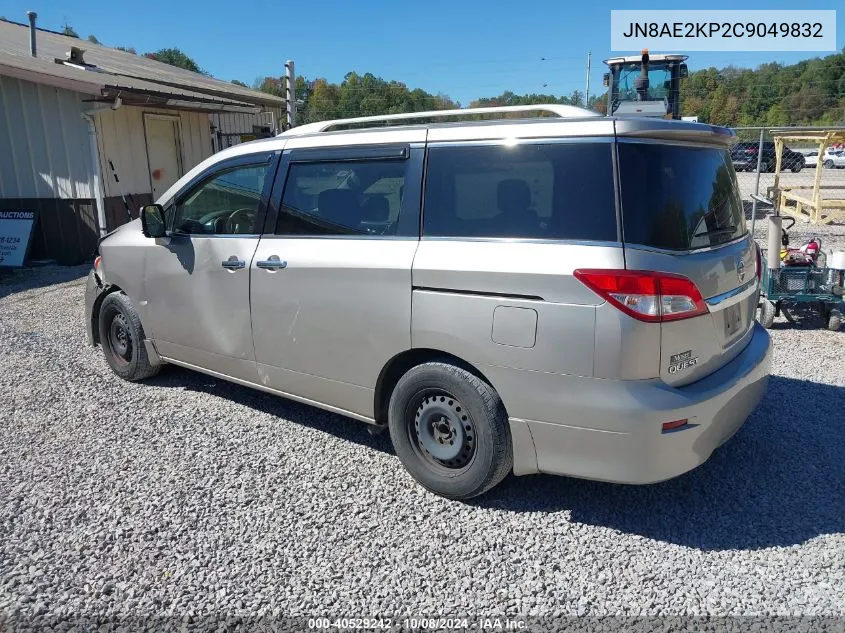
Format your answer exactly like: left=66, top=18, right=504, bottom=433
left=99, top=292, right=161, bottom=382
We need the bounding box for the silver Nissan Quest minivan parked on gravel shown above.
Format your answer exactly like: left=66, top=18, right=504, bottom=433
left=86, top=105, right=771, bottom=499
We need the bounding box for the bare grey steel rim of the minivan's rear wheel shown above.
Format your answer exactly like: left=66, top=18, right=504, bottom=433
left=414, top=394, right=475, bottom=469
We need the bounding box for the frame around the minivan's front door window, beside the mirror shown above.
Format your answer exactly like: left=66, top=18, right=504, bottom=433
left=165, top=151, right=281, bottom=239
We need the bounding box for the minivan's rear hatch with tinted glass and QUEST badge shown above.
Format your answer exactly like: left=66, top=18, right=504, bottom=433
left=618, top=139, right=759, bottom=385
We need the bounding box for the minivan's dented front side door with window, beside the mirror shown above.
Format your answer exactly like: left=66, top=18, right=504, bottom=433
left=144, top=157, right=270, bottom=381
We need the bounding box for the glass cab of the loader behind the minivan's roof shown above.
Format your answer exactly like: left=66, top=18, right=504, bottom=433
left=604, top=50, right=688, bottom=119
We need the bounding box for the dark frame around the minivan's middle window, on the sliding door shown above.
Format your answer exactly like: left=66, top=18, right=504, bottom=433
left=264, top=143, right=425, bottom=240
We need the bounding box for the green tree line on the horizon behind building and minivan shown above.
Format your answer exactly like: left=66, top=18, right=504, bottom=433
left=33, top=25, right=845, bottom=127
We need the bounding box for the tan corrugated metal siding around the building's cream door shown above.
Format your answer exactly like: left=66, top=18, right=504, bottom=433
left=97, top=106, right=211, bottom=197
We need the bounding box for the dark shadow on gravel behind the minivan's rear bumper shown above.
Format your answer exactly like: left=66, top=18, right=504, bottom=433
left=475, top=376, right=845, bottom=550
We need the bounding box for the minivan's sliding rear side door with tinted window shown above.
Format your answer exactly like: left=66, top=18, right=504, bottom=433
left=251, top=148, right=422, bottom=417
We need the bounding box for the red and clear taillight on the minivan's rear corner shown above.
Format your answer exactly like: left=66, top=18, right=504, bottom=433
left=573, top=269, right=707, bottom=323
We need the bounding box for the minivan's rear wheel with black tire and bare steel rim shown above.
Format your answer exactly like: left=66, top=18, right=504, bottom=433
left=388, top=362, right=513, bottom=499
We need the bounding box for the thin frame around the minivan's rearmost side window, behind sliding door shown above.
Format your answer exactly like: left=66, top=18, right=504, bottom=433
left=419, top=136, right=622, bottom=246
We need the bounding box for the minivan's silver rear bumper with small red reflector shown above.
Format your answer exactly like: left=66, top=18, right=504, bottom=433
left=494, top=322, right=772, bottom=484
